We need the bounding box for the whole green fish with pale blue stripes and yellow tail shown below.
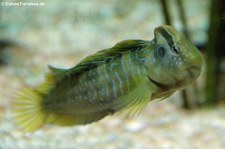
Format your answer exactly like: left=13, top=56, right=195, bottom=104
left=13, top=25, right=203, bottom=132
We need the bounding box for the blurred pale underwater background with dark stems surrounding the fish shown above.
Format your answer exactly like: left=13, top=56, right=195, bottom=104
left=0, top=0, right=225, bottom=149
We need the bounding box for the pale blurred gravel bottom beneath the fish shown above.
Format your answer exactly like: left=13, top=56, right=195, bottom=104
left=0, top=101, right=225, bottom=149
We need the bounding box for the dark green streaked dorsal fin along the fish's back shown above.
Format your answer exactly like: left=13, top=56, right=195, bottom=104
left=68, top=40, right=150, bottom=75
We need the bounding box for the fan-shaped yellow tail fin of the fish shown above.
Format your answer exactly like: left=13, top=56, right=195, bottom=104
left=14, top=88, right=46, bottom=132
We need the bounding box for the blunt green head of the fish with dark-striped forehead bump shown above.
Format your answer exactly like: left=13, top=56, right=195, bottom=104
left=148, top=25, right=203, bottom=89
